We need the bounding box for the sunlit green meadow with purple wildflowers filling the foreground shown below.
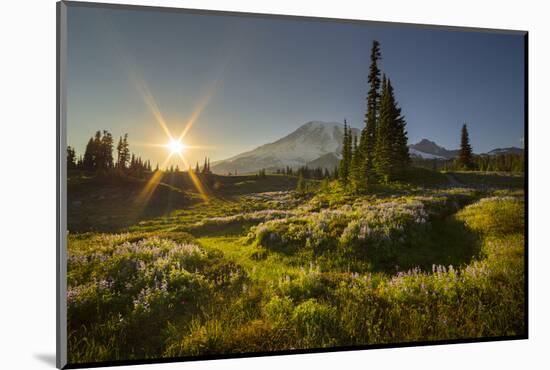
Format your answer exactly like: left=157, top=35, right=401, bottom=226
left=67, top=169, right=526, bottom=363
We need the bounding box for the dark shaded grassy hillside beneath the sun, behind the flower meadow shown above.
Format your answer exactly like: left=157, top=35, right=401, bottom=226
left=67, top=172, right=297, bottom=232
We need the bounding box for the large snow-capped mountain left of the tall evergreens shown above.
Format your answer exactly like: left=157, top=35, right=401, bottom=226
left=212, top=121, right=360, bottom=174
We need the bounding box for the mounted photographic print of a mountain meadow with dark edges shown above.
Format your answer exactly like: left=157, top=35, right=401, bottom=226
left=57, top=2, right=527, bottom=368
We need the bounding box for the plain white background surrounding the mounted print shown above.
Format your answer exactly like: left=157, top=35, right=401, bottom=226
left=0, top=0, right=550, bottom=370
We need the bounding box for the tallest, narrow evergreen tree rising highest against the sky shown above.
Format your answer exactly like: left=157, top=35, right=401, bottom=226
left=356, top=40, right=380, bottom=185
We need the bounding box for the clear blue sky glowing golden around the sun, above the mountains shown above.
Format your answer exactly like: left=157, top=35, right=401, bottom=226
left=67, top=6, right=524, bottom=167
